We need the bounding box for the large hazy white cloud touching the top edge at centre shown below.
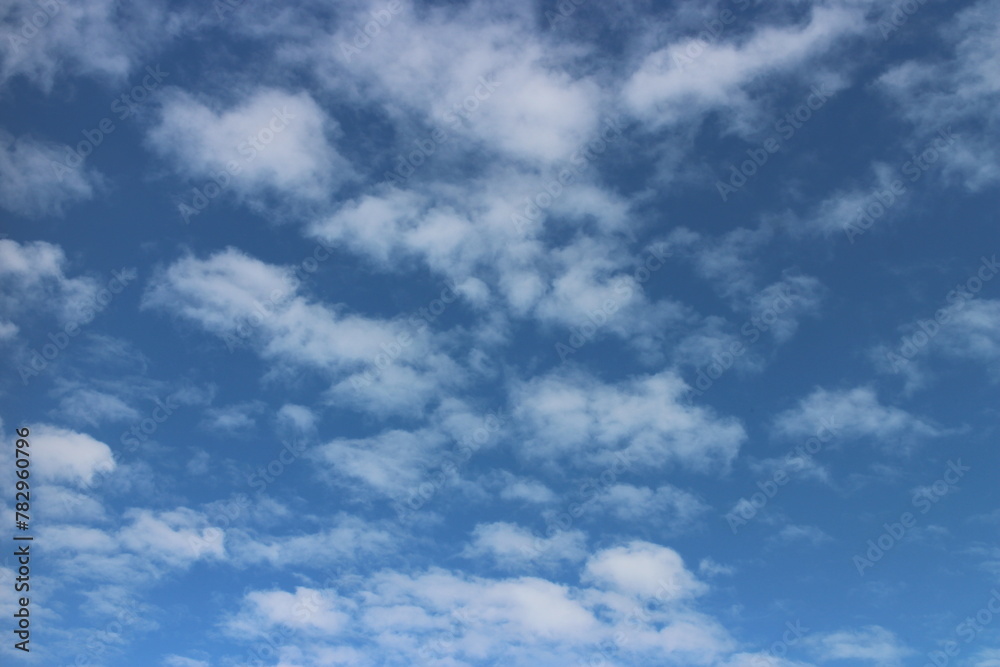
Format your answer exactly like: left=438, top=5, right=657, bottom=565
left=310, top=2, right=602, bottom=166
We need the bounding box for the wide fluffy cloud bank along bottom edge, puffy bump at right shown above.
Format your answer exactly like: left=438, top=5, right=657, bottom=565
left=226, top=540, right=748, bottom=667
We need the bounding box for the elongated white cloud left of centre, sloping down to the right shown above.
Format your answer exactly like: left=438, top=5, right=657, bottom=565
left=143, top=248, right=462, bottom=414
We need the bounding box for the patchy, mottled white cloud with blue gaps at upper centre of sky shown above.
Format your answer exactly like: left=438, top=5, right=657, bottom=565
left=310, top=183, right=693, bottom=366
